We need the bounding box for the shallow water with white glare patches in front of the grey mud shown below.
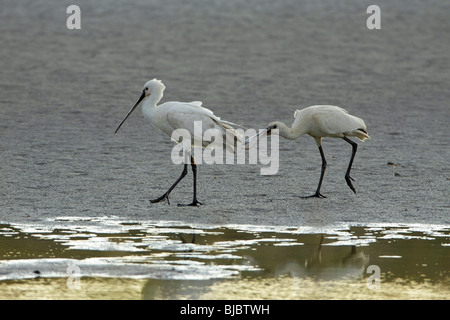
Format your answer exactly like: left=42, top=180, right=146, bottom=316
left=0, top=217, right=450, bottom=299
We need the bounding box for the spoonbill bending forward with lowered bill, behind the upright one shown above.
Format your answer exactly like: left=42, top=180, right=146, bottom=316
left=246, top=105, right=370, bottom=198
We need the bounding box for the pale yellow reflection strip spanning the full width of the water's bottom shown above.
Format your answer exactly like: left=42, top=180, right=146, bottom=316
left=0, top=276, right=450, bottom=300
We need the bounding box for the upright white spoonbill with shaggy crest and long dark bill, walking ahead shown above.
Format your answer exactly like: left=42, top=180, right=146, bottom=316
left=115, top=79, right=242, bottom=206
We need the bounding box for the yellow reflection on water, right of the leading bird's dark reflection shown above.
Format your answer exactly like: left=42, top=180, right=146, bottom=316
left=201, top=277, right=450, bottom=300
